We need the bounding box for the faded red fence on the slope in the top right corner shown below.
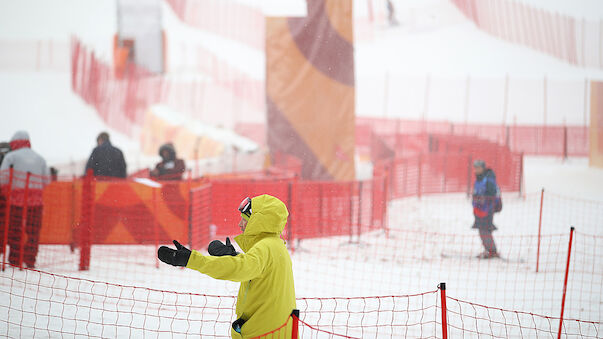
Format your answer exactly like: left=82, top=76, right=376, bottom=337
left=452, top=0, right=603, bottom=68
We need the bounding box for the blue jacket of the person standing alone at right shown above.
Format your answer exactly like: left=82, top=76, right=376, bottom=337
left=472, top=168, right=500, bottom=230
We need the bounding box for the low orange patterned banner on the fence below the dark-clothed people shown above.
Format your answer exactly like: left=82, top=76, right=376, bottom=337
left=40, top=180, right=189, bottom=244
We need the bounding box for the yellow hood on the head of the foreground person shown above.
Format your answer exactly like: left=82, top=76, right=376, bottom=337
left=235, top=194, right=289, bottom=252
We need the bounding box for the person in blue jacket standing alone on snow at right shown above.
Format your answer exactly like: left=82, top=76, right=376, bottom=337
left=472, top=160, right=500, bottom=259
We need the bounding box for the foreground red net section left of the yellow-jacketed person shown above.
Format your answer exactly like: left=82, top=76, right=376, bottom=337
left=0, top=268, right=236, bottom=338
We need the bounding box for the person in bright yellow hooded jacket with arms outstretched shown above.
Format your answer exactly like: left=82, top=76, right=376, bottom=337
left=157, top=194, right=296, bottom=338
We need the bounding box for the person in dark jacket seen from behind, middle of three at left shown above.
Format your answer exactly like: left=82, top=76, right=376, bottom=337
left=84, top=132, right=126, bottom=178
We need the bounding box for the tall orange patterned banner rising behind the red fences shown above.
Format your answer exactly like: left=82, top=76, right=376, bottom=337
left=266, top=0, right=355, bottom=181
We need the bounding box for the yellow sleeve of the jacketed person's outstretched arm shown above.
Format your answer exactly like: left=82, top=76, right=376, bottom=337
left=186, top=244, right=268, bottom=282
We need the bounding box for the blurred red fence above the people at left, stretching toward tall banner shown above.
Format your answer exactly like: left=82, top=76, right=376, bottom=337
left=70, top=38, right=263, bottom=135
